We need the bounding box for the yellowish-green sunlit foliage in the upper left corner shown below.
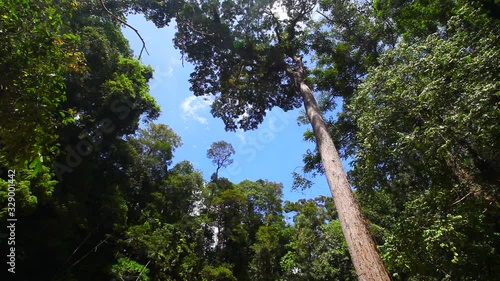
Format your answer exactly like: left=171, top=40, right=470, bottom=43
left=0, top=0, right=85, bottom=167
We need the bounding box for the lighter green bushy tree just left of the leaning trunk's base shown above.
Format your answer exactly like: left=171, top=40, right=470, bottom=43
left=281, top=197, right=356, bottom=280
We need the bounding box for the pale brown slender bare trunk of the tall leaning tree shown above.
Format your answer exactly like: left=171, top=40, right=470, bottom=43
left=293, top=57, right=390, bottom=281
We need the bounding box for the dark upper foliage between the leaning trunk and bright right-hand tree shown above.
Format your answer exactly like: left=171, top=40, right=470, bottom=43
left=297, top=0, right=390, bottom=176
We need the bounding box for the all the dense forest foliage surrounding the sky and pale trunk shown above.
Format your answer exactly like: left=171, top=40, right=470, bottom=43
left=0, top=0, right=500, bottom=280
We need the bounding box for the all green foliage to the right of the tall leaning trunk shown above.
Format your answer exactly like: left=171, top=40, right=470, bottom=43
left=296, top=1, right=500, bottom=280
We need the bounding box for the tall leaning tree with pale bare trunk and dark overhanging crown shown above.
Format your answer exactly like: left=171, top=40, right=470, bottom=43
left=139, top=0, right=389, bottom=280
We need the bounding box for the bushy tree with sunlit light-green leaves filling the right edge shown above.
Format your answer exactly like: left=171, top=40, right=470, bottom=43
left=349, top=6, right=500, bottom=280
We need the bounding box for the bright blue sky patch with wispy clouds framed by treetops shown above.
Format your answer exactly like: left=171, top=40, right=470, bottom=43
left=123, top=15, right=331, bottom=201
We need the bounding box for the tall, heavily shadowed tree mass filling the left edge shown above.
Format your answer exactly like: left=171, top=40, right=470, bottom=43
left=4, top=1, right=159, bottom=280
